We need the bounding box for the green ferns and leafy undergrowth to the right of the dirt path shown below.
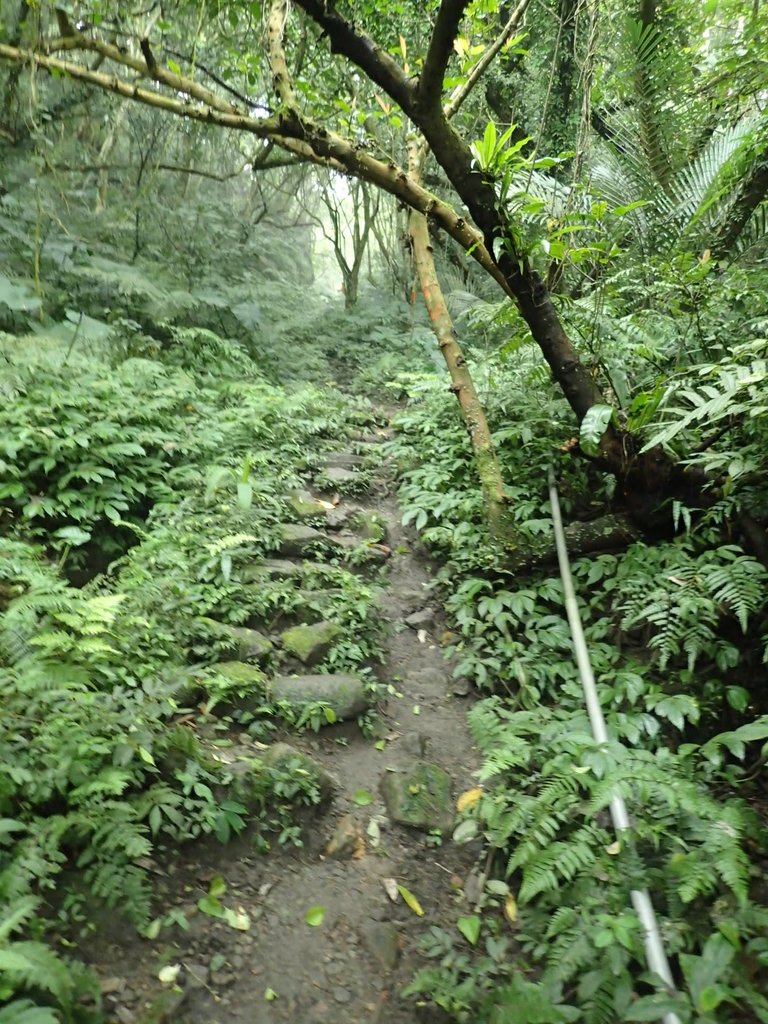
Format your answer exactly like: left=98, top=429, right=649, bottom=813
left=392, top=356, right=768, bottom=1024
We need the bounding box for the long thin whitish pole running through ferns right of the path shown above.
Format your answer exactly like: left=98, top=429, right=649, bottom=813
left=549, top=469, right=680, bottom=1024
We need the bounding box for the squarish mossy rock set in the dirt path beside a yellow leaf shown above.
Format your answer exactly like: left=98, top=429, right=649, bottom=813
left=381, top=761, right=454, bottom=831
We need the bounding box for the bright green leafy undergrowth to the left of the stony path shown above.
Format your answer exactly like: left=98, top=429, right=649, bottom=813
left=0, top=299, right=421, bottom=1024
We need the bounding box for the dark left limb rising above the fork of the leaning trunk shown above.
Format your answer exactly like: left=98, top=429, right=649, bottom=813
left=294, top=0, right=416, bottom=114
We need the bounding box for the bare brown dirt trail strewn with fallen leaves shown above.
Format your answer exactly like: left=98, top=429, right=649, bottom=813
left=79, top=413, right=482, bottom=1024
